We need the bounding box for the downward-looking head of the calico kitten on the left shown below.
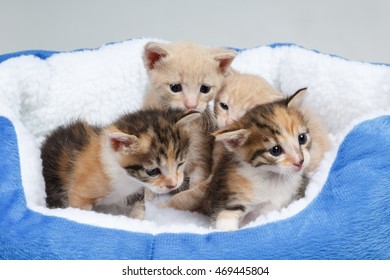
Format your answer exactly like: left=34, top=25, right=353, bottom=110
left=107, top=110, right=200, bottom=194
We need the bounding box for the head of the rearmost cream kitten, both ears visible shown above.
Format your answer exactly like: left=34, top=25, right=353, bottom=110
left=144, top=42, right=236, bottom=112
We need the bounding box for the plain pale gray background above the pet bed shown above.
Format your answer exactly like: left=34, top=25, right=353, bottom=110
left=0, top=0, right=390, bottom=63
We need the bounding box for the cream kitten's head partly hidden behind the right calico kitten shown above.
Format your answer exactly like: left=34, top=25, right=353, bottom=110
left=214, top=73, right=282, bottom=128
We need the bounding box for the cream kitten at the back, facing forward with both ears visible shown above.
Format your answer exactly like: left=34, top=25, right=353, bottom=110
left=143, top=42, right=236, bottom=195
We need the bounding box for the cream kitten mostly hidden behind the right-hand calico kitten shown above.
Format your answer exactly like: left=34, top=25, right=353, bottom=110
left=214, top=72, right=330, bottom=172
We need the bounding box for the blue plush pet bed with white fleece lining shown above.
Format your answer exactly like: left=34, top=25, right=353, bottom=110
left=0, top=38, right=390, bottom=259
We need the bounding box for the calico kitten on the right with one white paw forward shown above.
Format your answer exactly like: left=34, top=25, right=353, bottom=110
left=166, top=90, right=313, bottom=230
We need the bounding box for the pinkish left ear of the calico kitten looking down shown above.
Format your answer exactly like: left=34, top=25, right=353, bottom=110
left=107, top=132, right=139, bottom=154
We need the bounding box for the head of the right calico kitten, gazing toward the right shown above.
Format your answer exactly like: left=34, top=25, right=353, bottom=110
left=215, top=88, right=311, bottom=175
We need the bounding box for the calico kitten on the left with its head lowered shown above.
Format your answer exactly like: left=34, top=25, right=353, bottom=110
left=41, top=106, right=200, bottom=218
